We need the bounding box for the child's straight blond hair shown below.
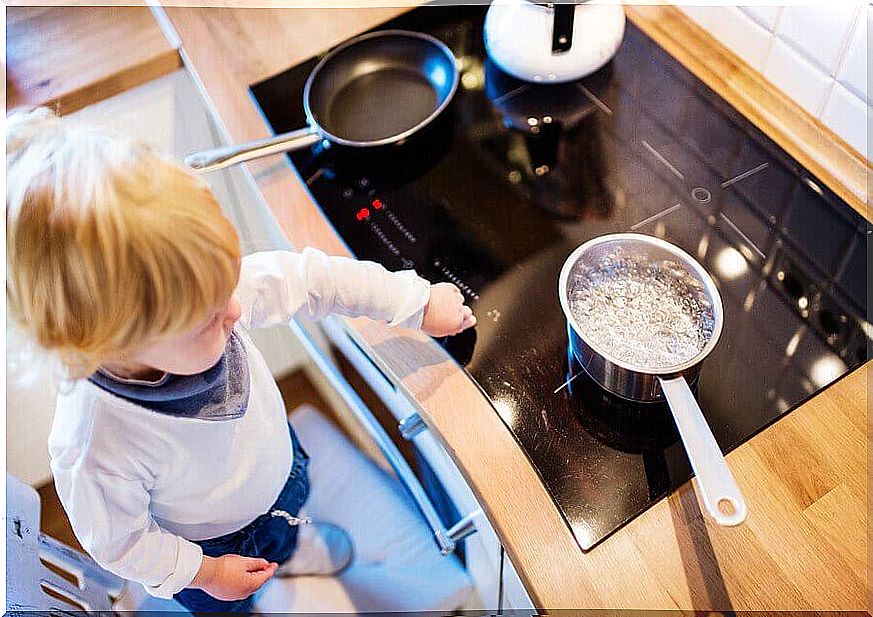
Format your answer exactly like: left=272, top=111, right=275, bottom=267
left=6, top=108, right=240, bottom=377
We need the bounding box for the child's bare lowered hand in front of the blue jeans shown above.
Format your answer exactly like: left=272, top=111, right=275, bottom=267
left=190, top=555, right=278, bottom=600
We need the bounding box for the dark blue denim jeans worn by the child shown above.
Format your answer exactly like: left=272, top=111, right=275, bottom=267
left=175, top=424, right=309, bottom=613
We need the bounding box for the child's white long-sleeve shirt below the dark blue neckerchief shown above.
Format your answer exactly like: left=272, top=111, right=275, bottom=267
left=49, top=249, right=430, bottom=598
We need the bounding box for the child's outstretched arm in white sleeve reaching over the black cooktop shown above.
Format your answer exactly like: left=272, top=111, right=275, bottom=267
left=235, top=248, right=475, bottom=336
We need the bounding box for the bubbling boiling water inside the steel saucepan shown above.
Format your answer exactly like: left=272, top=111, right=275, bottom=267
left=567, top=249, right=715, bottom=371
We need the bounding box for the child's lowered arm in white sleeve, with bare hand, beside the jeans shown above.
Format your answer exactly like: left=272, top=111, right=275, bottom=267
left=52, top=460, right=277, bottom=600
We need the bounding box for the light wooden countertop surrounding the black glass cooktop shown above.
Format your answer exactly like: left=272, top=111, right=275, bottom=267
left=20, top=6, right=870, bottom=610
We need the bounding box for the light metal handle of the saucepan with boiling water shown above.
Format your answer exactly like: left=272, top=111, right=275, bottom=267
left=659, top=377, right=746, bottom=526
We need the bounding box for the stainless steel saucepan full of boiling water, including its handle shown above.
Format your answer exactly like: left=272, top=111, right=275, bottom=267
left=558, top=233, right=746, bottom=525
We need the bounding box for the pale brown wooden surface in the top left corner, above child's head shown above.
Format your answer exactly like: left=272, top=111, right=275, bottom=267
left=6, top=6, right=182, bottom=114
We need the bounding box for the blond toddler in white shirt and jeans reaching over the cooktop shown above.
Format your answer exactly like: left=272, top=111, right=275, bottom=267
left=6, top=109, right=476, bottom=611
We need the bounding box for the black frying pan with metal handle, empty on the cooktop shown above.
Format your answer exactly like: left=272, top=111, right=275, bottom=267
left=185, top=30, right=458, bottom=171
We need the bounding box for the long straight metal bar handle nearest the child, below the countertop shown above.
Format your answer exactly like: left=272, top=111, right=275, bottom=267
left=288, top=320, right=455, bottom=555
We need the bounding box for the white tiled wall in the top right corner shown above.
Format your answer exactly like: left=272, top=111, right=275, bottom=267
left=681, top=0, right=873, bottom=160
